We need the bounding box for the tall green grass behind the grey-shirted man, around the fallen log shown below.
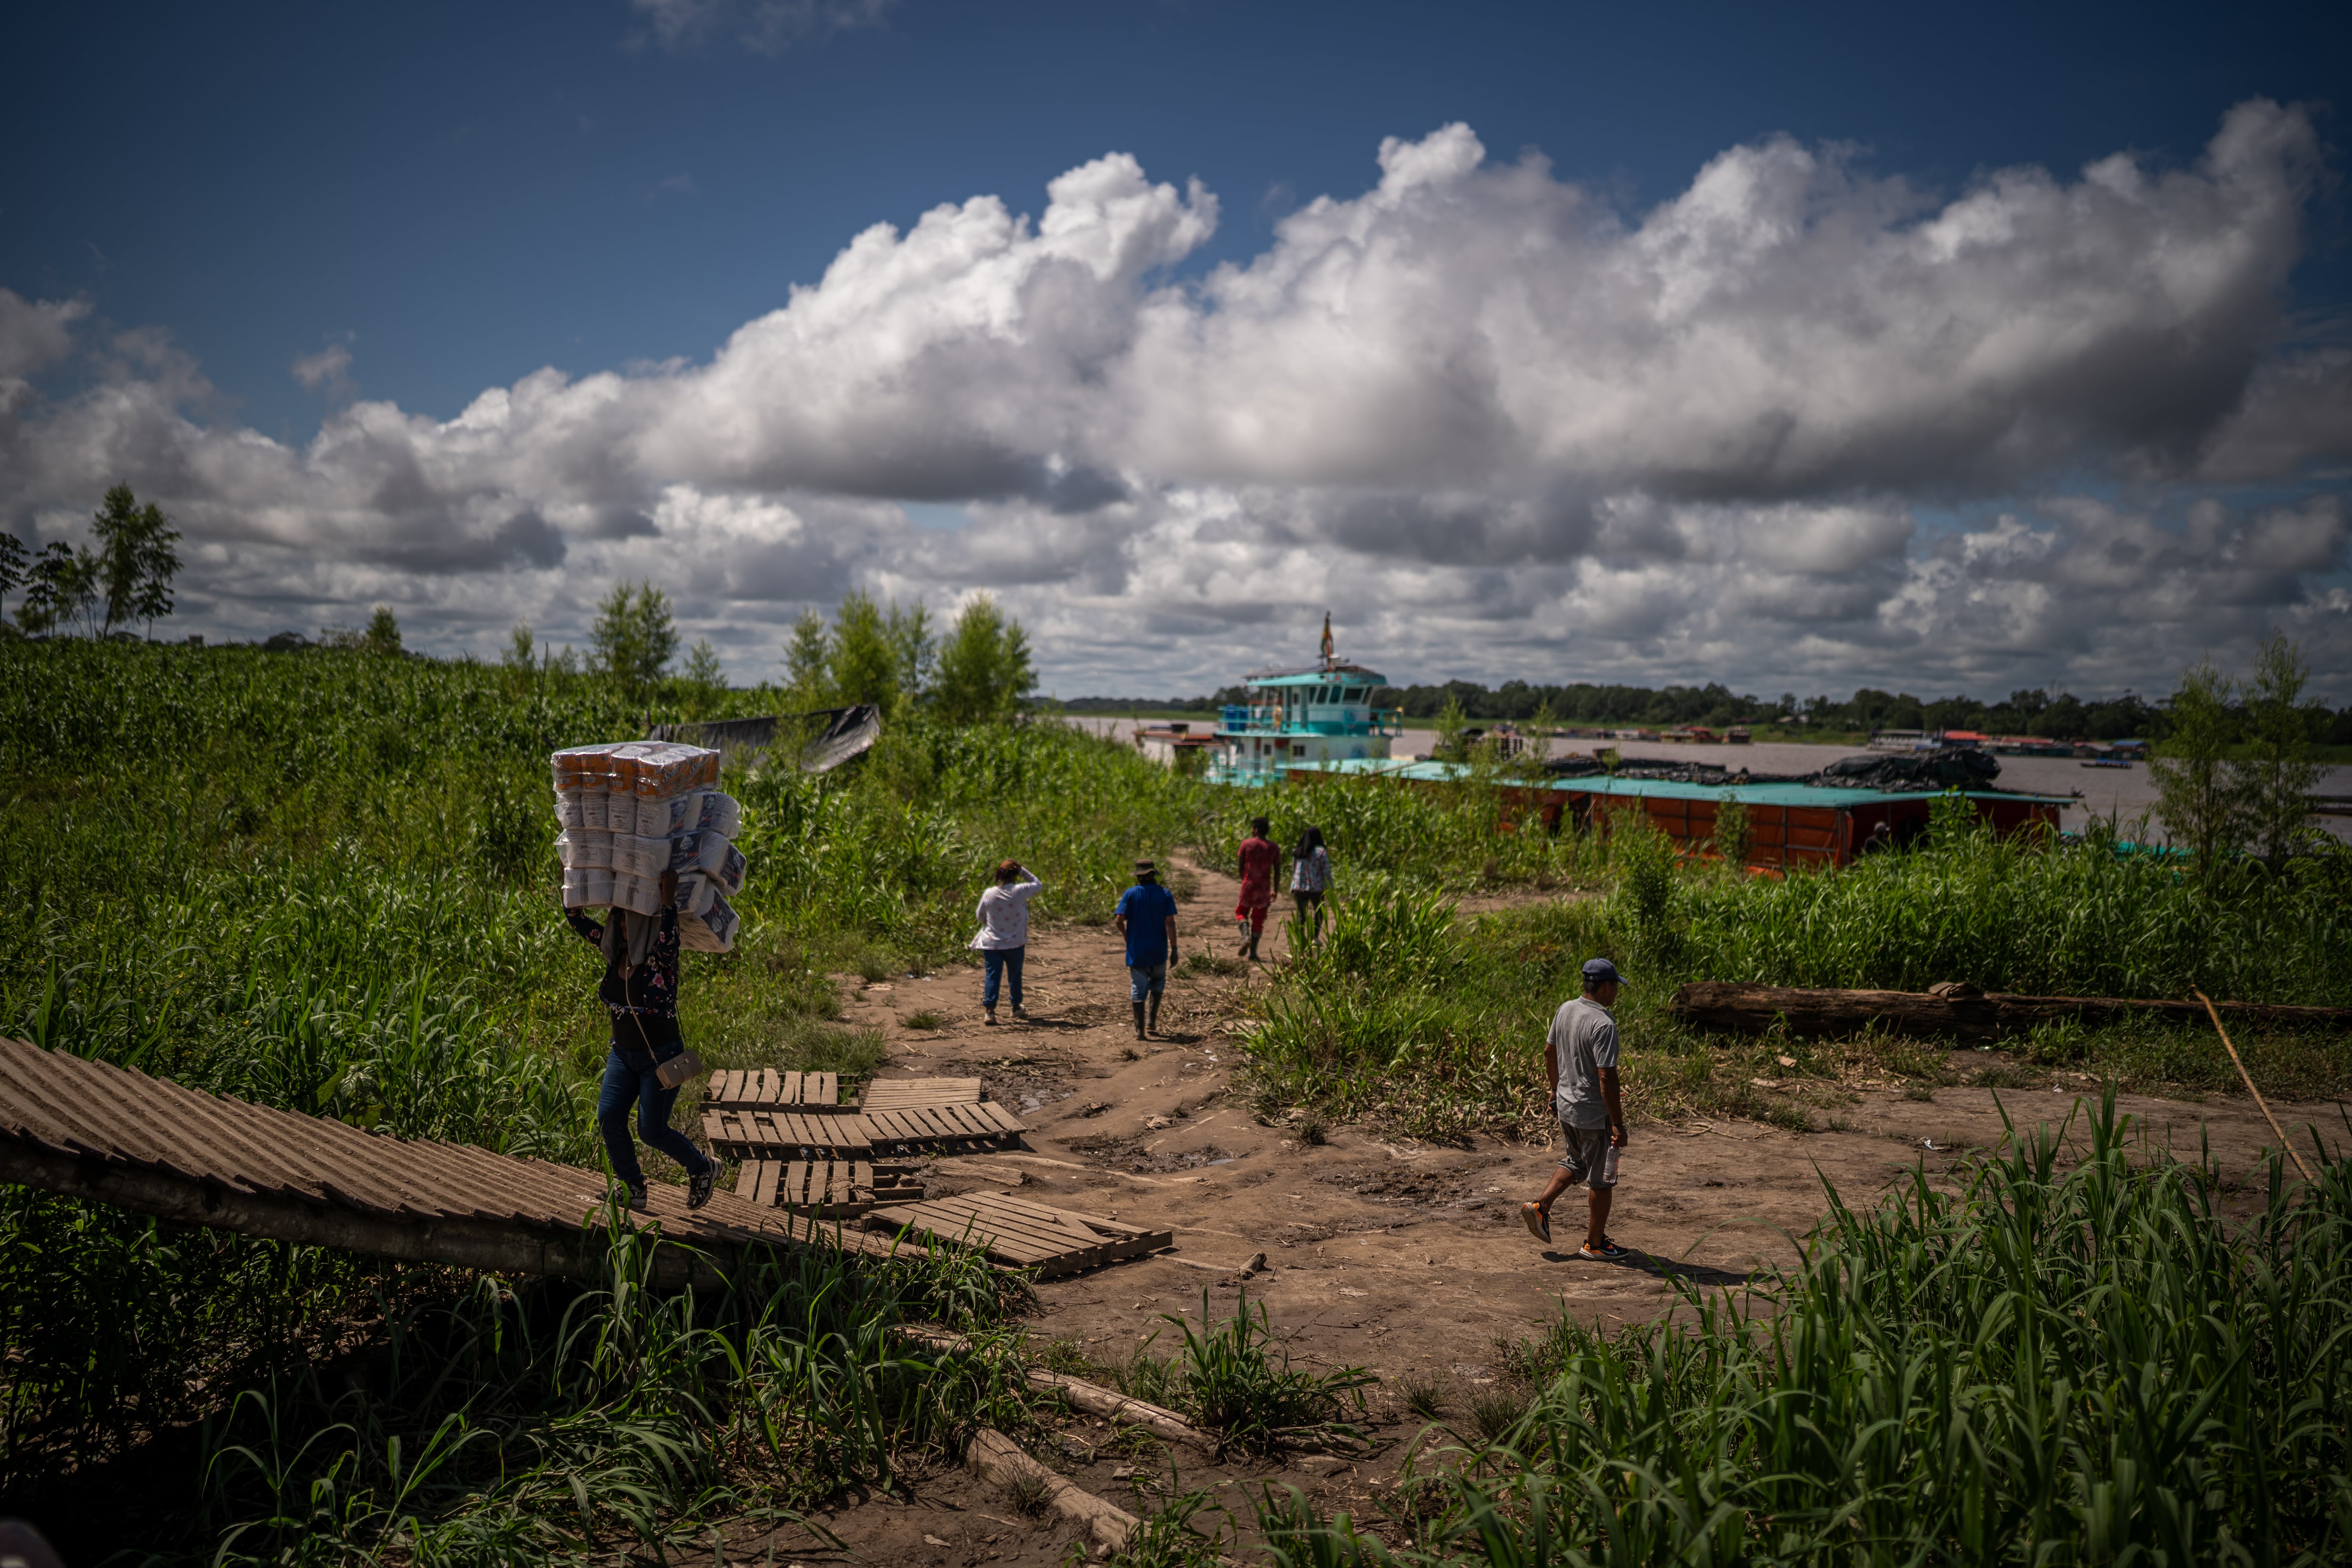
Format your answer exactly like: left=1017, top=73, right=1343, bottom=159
left=1247, top=780, right=2352, bottom=1136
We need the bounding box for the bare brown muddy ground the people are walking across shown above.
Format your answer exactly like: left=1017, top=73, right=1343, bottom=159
left=729, top=868, right=2345, bottom=1566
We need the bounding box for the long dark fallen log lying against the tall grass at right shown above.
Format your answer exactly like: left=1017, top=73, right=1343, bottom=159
left=1670, top=980, right=2352, bottom=1042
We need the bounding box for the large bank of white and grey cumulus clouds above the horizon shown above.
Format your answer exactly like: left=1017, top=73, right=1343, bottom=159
left=0, top=104, right=2352, bottom=696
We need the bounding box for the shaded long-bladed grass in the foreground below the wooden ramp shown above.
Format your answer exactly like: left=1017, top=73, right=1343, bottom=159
left=191, top=1227, right=1025, bottom=1566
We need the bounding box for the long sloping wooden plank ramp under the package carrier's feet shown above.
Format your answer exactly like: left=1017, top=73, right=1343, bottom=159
left=0, top=1039, right=917, bottom=1283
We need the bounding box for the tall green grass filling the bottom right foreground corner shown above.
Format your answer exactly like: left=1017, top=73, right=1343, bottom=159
left=1261, top=1091, right=2352, bottom=1568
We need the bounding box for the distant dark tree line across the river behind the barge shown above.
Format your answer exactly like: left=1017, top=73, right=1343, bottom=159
left=1063, top=679, right=2352, bottom=745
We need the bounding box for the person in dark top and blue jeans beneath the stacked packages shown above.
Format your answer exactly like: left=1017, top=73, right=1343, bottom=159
left=564, top=872, right=720, bottom=1208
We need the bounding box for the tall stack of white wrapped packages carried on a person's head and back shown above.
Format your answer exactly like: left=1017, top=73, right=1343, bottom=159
left=548, top=740, right=743, bottom=952
